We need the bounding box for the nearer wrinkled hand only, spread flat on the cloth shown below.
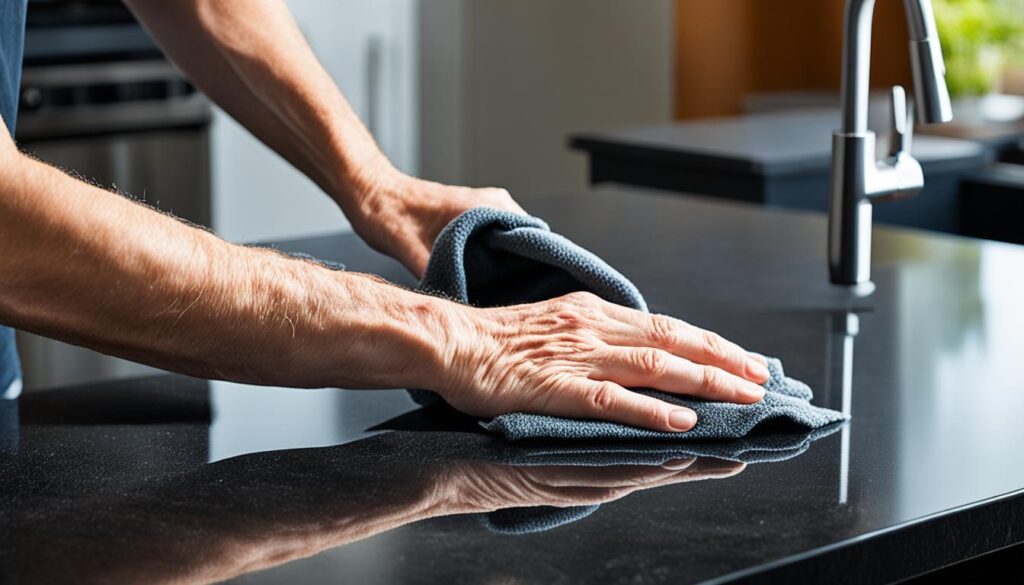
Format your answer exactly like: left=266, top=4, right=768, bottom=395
left=436, top=293, right=769, bottom=432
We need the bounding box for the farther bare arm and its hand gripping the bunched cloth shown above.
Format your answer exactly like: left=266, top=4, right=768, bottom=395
left=126, top=0, right=522, bottom=277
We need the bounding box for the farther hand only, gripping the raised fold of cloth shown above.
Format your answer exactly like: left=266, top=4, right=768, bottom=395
left=349, top=174, right=525, bottom=278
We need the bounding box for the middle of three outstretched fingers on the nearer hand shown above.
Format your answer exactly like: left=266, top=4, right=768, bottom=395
left=591, top=347, right=765, bottom=404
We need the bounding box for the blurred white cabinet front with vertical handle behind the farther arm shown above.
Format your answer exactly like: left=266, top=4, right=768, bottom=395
left=211, top=0, right=417, bottom=242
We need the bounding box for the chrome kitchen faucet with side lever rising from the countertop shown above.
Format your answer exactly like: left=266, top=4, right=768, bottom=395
left=828, top=0, right=952, bottom=285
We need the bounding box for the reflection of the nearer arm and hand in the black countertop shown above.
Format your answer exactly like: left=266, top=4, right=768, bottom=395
left=6, top=432, right=744, bottom=583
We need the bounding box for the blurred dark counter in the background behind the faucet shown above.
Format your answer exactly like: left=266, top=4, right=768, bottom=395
left=569, top=109, right=995, bottom=235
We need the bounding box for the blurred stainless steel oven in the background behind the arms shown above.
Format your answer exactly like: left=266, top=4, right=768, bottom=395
left=16, top=0, right=211, bottom=389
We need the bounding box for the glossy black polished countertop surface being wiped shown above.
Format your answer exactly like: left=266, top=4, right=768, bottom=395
left=0, top=190, right=1024, bottom=583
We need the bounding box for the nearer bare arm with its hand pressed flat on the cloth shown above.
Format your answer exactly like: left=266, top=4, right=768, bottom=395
left=0, top=131, right=768, bottom=431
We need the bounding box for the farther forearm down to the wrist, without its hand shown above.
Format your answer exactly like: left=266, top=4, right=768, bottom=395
left=119, top=0, right=391, bottom=215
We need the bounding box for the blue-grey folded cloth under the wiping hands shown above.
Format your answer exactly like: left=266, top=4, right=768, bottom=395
left=411, top=207, right=846, bottom=441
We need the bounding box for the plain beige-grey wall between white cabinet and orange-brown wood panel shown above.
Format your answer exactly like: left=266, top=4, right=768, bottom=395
left=420, top=0, right=674, bottom=195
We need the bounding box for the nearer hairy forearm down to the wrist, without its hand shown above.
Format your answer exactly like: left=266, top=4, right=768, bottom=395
left=0, top=147, right=455, bottom=387
